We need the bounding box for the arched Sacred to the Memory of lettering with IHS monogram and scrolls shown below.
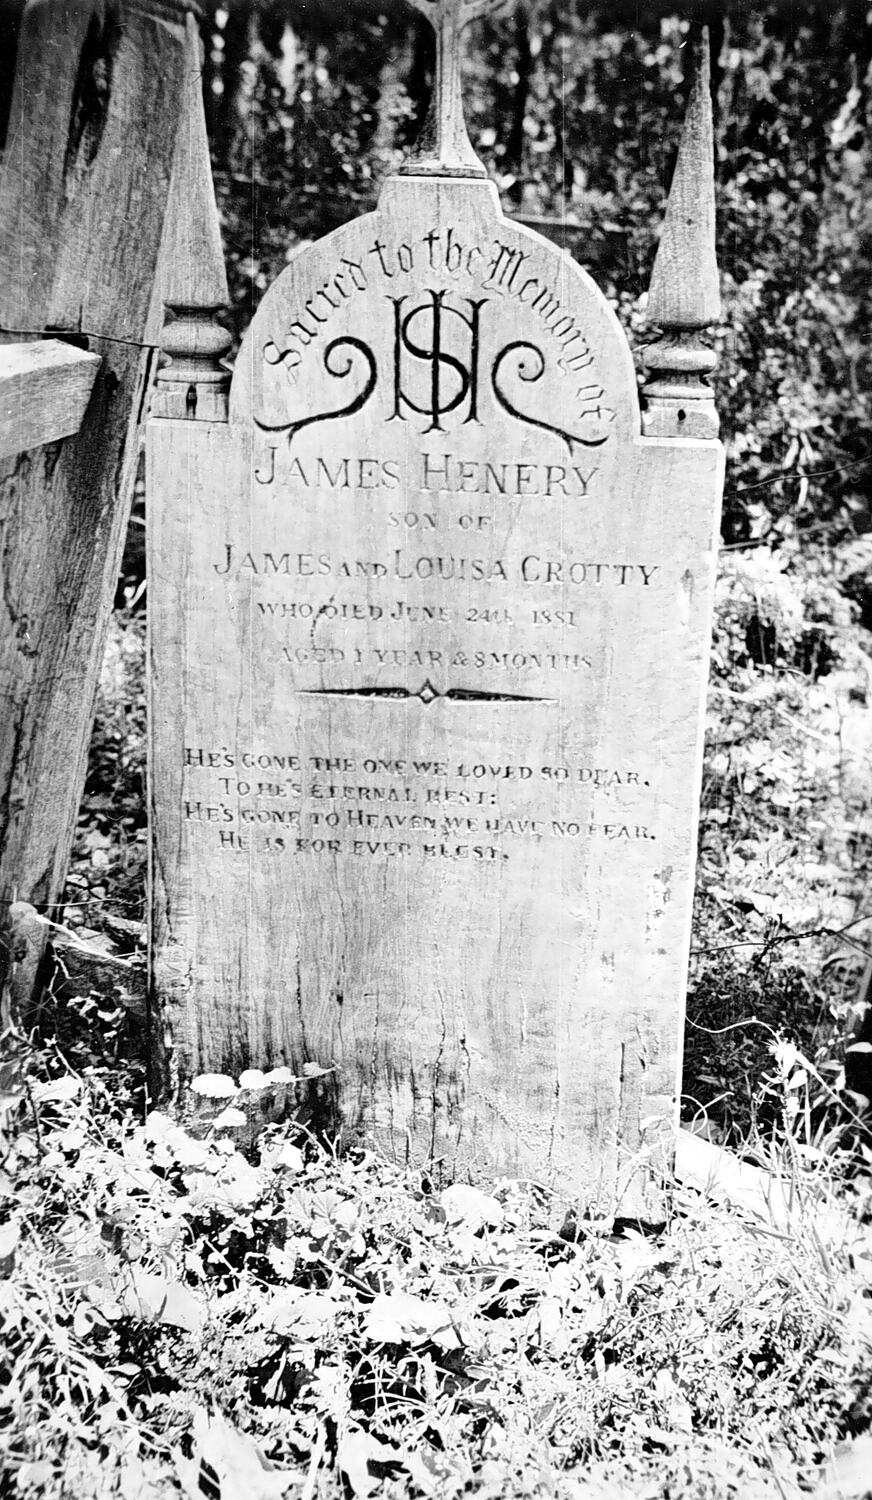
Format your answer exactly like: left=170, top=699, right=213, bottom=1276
left=254, top=227, right=615, bottom=453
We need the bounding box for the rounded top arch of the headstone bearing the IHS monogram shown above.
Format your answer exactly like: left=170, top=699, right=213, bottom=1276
left=230, top=176, right=639, bottom=473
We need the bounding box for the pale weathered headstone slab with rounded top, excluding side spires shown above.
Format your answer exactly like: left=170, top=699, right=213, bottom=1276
left=149, top=0, right=722, bottom=1217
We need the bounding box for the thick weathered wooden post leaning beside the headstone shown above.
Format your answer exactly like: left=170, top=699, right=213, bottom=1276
left=0, top=0, right=191, bottom=996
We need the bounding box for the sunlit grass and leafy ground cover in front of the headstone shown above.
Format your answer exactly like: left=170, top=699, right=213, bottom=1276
left=0, top=1023, right=872, bottom=1500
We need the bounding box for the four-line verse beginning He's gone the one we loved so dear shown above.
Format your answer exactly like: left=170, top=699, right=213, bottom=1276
left=182, top=746, right=656, bottom=864
